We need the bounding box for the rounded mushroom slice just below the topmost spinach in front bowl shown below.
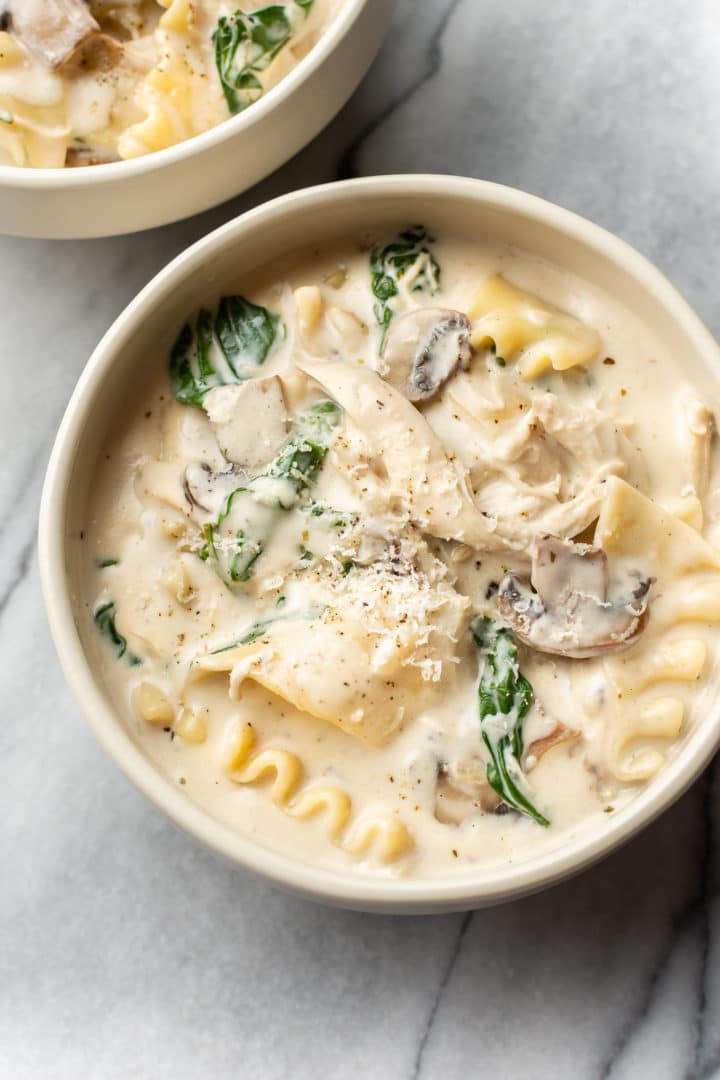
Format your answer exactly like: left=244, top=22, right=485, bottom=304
left=380, top=308, right=472, bottom=402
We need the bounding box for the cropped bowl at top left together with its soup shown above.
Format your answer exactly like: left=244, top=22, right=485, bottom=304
left=0, top=0, right=394, bottom=238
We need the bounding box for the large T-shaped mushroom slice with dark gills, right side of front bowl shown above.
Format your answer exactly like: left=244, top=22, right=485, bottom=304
left=498, top=536, right=652, bottom=660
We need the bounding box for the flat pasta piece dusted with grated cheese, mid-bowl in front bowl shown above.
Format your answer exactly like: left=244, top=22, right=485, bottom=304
left=193, top=548, right=470, bottom=745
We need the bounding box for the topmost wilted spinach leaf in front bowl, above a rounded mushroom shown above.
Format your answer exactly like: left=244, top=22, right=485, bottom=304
left=370, top=225, right=440, bottom=349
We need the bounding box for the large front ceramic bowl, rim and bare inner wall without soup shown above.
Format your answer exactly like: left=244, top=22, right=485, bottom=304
left=40, top=176, right=720, bottom=913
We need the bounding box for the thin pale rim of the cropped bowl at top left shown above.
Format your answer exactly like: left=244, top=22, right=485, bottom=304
left=0, top=0, right=369, bottom=190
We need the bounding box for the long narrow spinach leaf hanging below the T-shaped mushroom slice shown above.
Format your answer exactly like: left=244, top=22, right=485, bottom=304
left=470, top=617, right=549, bottom=826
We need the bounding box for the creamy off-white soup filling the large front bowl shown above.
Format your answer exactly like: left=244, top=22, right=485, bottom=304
left=84, top=233, right=720, bottom=877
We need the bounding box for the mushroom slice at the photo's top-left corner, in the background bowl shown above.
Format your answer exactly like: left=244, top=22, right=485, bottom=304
left=0, top=0, right=106, bottom=68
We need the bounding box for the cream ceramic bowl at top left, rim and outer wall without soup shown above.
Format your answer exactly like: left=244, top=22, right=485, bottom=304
left=0, top=0, right=394, bottom=239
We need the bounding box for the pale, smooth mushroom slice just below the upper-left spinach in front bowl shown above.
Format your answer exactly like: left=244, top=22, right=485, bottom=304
left=204, top=375, right=289, bottom=473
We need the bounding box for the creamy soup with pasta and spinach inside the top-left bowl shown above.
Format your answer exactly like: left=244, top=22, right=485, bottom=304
left=0, top=0, right=344, bottom=168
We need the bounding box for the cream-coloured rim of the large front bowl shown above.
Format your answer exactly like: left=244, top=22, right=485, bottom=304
left=39, top=174, right=720, bottom=913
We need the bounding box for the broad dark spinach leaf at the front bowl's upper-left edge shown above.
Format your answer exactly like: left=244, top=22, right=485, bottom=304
left=169, top=296, right=285, bottom=405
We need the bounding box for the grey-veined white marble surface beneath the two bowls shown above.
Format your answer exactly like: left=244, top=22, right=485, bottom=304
left=0, top=0, right=720, bottom=1080
